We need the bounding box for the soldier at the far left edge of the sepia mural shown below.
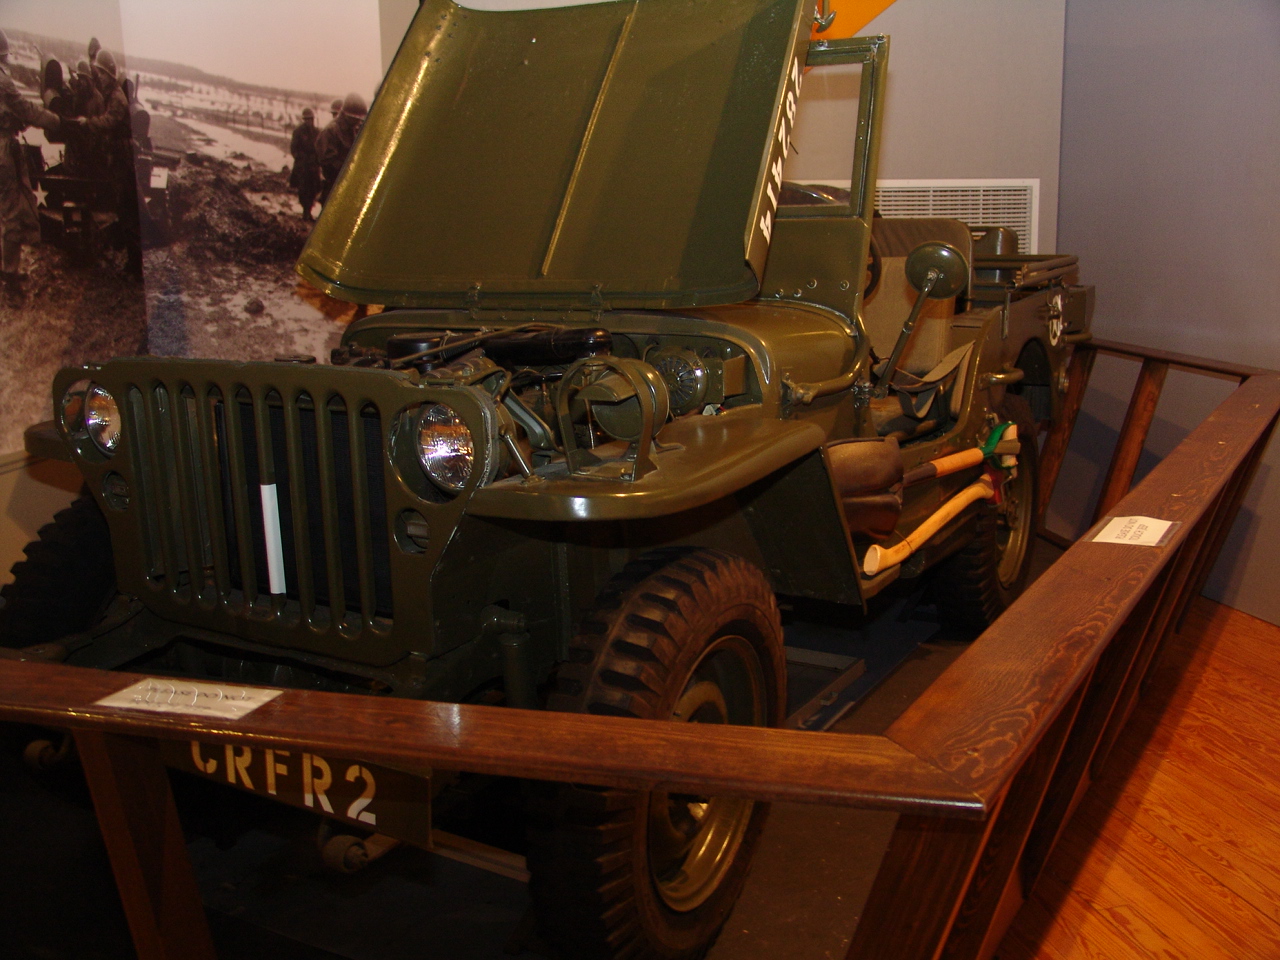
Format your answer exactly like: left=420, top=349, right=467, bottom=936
left=0, top=31, right=59, bottom=303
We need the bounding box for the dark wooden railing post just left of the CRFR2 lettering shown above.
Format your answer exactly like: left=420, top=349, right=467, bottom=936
left=76, top=730, right=216, bottom=960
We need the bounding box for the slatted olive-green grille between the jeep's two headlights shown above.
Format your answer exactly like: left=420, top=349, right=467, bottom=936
left=123, top=380, right=393, bottom=636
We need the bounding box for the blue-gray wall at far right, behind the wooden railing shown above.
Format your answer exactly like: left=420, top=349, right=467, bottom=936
left=1059, top=0, right=1280, bottom=622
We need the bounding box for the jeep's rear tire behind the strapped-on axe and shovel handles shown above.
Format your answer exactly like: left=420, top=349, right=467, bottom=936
left=932, top=396, right=1039, bottom=632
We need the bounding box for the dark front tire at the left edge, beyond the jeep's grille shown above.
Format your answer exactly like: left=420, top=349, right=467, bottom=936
left=0, top=497, right=116, bottom=648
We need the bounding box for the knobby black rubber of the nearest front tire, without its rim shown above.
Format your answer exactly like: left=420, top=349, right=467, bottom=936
left=529, top=548, right=785, bottom=960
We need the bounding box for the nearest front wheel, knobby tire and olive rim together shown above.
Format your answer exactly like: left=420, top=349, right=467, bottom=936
left=529, top=548, right=786, bottom=960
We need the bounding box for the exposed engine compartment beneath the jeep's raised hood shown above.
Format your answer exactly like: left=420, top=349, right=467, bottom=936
left=330, top=323, right=760, bottom=499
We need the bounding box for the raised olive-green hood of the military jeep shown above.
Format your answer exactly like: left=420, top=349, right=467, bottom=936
left=298, top=0, right=813, bottom=308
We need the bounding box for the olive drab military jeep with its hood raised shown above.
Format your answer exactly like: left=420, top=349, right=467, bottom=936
left=0, top=0, right=1092, bottom=957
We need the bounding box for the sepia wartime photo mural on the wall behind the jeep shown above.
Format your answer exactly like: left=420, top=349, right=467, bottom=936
left=0, top=0, right=381, bottom=458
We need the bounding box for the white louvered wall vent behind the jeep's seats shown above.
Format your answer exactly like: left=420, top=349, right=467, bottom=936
left=876, top=178, right=1039, bottom=253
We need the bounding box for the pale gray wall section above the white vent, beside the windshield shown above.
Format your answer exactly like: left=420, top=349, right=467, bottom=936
left=846, top=0, right=1065, bottom=252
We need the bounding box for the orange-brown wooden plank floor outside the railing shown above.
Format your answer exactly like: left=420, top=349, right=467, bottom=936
left=997, top=599, right=1280, bottom=960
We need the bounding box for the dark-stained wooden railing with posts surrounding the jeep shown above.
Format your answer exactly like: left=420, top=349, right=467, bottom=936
left=0, top=342, right=1280, bottom=960
